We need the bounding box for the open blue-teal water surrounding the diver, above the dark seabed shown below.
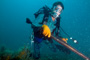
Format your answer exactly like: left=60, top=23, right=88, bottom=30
left=0, top=0, right=90, bottom=59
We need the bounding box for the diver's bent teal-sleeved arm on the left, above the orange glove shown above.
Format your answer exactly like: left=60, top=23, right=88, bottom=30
left=26, top=14, right=44, bottom=32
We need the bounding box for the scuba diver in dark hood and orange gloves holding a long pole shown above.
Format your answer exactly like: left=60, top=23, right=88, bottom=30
left=26, top=1, right=68, bottom=59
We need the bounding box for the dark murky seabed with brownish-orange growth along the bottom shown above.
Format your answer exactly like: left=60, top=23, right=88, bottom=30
left=0, top=46, right=87, bottom=60
